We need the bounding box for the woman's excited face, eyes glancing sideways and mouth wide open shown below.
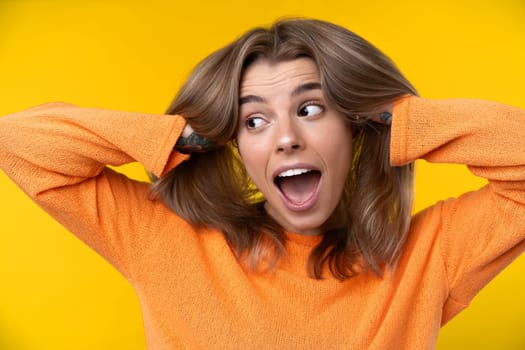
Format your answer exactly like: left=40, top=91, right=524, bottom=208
left=237, top=58, right=352, bottom=235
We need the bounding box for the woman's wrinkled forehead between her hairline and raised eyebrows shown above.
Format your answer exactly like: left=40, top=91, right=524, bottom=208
left=240, top=58, right=320, bottom=96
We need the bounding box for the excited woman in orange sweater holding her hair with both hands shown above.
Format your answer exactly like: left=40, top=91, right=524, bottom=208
left=0, top=20, right=525, bottom=349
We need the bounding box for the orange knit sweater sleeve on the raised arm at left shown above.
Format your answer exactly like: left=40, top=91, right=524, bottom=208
left=0, top=103, right=188, bottom=278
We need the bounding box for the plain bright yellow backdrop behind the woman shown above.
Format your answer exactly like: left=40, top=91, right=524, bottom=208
left=0, top=0, right=525, bottom=350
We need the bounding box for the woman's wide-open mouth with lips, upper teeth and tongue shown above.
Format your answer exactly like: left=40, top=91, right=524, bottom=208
left=274, top=168, right=321, bottom=210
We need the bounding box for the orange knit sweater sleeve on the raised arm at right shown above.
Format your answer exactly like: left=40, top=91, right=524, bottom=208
left=391, top=97, right=525, bottom=323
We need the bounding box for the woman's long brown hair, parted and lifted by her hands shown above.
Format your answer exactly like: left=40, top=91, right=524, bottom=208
left=152, top=19, right=416, bottom=279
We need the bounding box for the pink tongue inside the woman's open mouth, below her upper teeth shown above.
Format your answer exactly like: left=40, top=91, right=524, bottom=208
left=279, top=171, right=321, bottom=204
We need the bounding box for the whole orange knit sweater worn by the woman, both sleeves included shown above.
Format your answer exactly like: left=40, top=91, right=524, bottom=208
left=0, top=97, right=525, bottom=350
